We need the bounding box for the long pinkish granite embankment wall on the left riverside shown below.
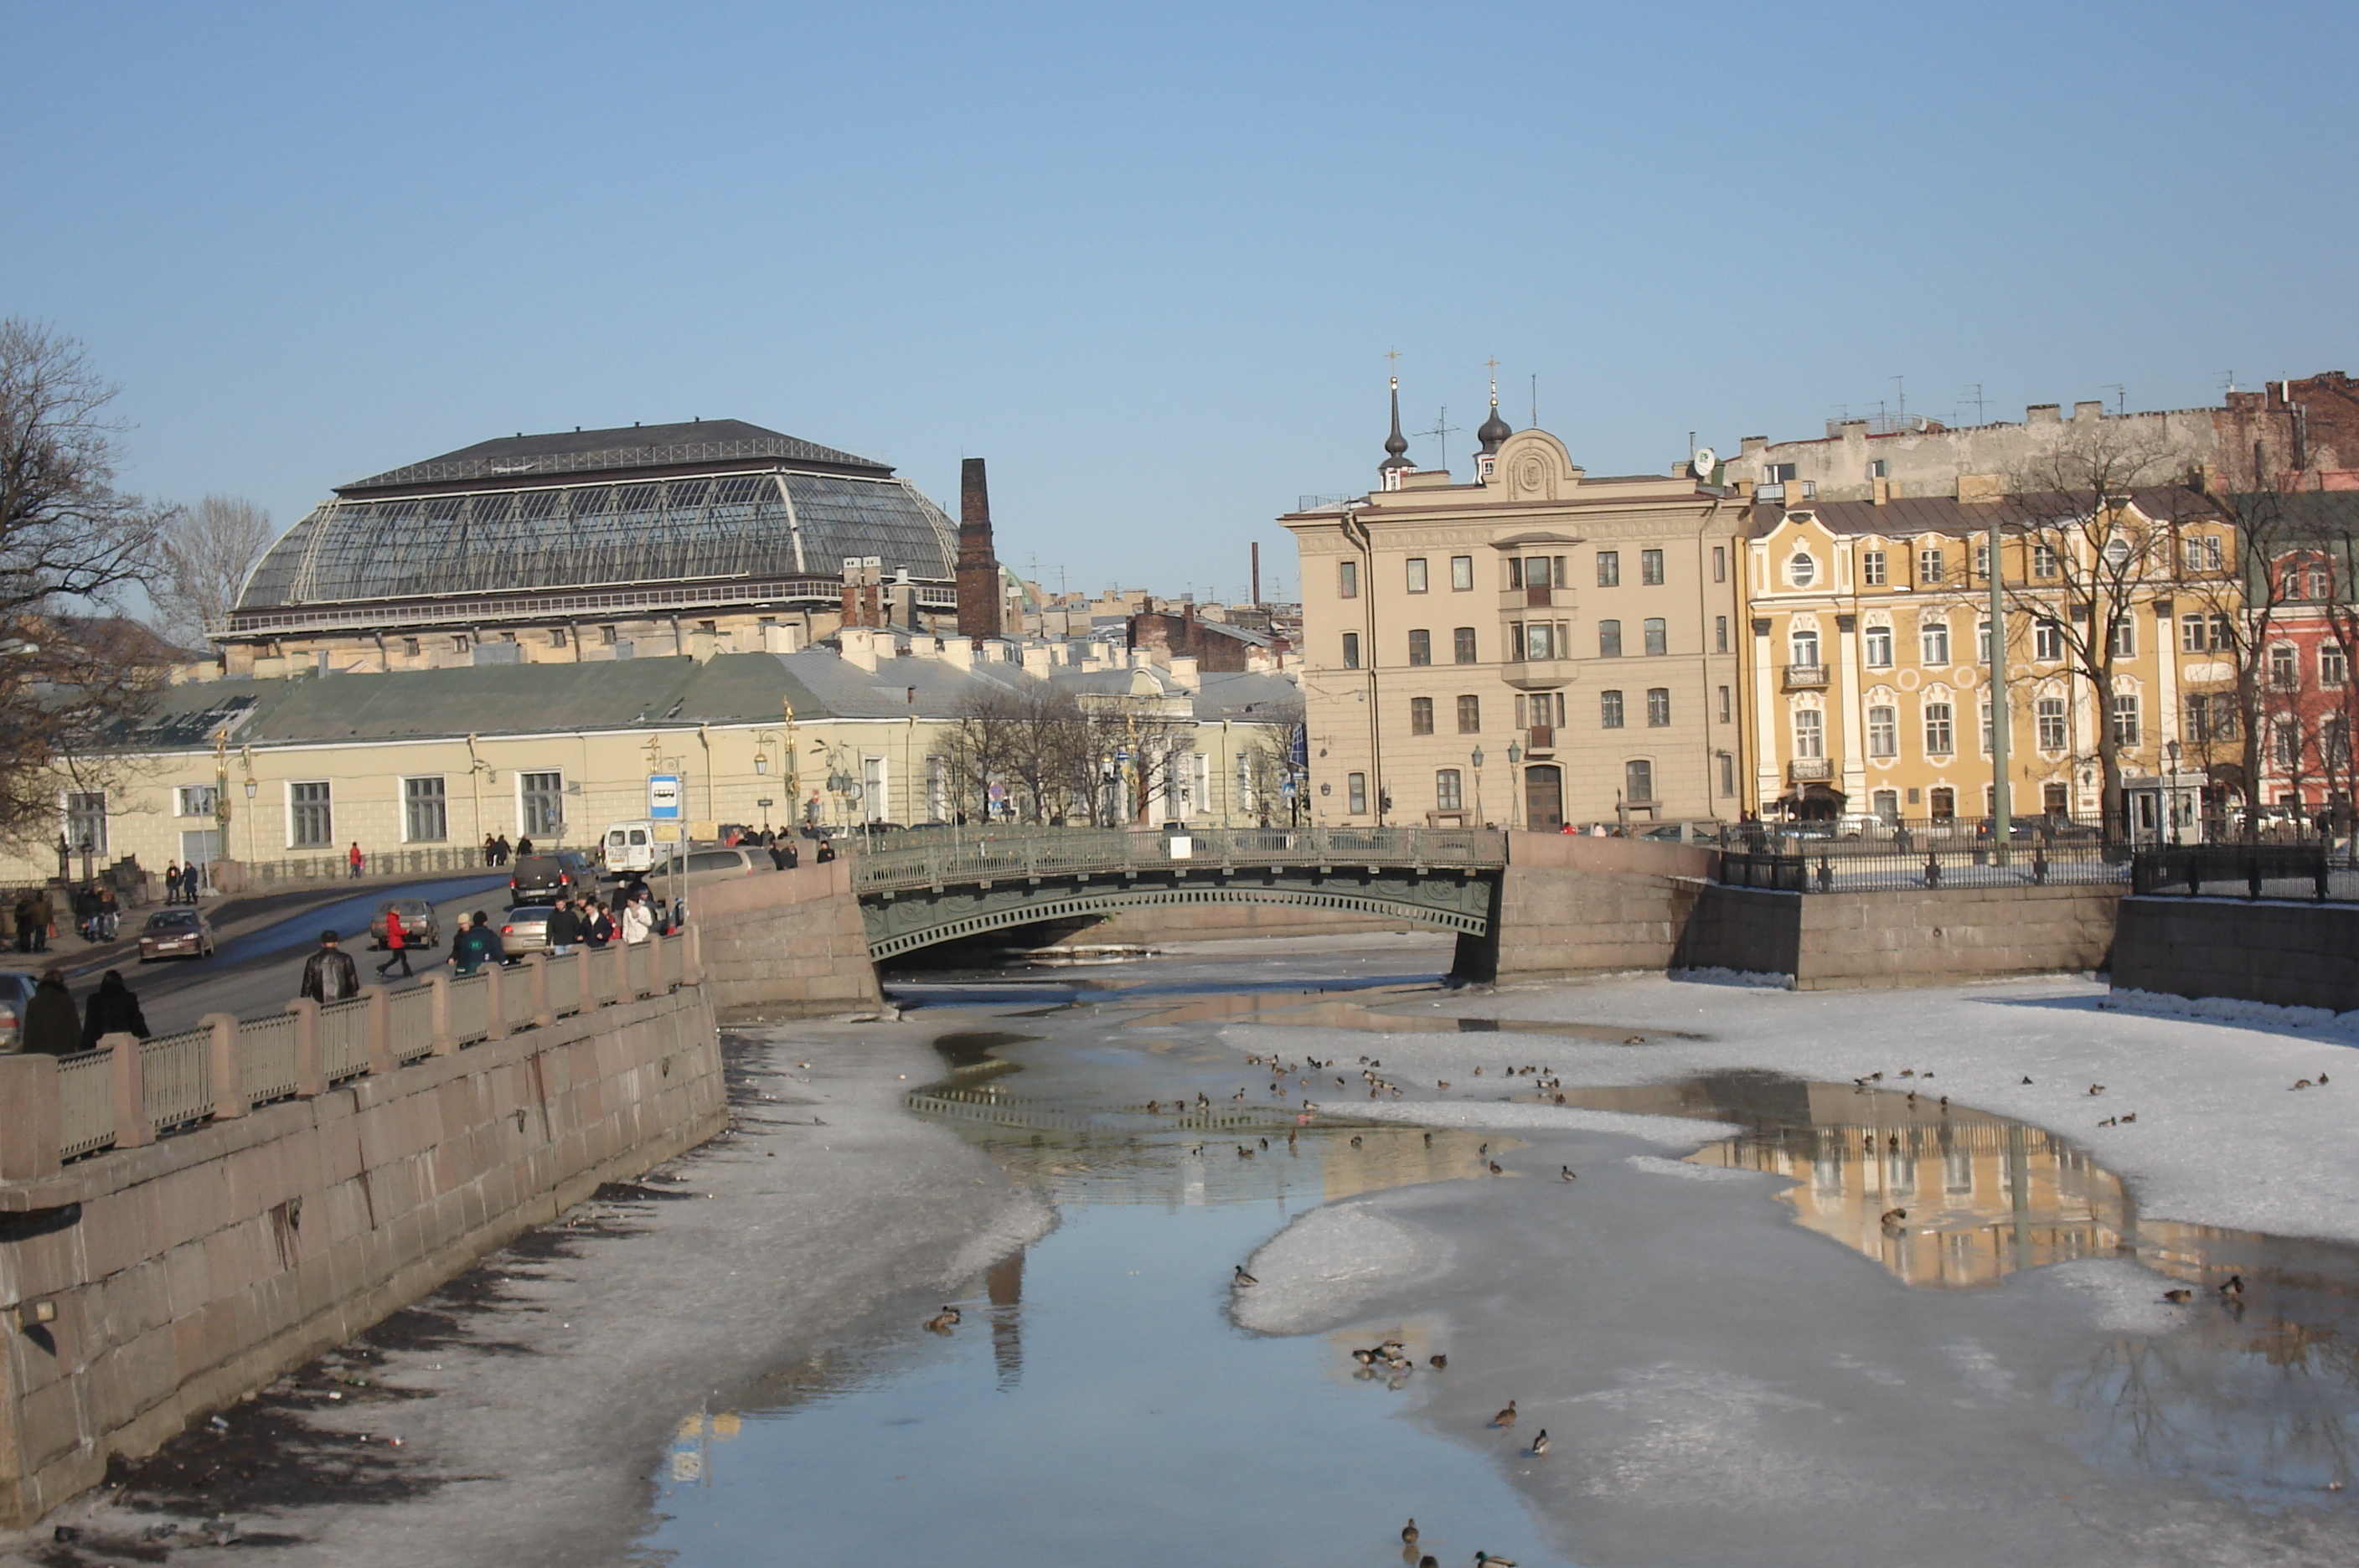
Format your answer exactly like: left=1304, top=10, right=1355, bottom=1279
left=0, top=971, right=729, bottom=1524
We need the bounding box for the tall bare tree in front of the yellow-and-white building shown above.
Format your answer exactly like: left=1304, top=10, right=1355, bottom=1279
left=2007, top=420, right=2191, bottom=835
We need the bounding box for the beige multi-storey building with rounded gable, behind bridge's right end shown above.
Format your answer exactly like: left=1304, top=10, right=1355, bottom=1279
left=1278, top=391, right=1746, bottom=830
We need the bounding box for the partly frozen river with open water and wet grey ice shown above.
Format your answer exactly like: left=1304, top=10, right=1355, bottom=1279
left=644, top=952, right=2359, bottom=1568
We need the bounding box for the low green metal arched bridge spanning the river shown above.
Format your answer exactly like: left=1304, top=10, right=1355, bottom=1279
left=852, top=828, right=1507, bottom=960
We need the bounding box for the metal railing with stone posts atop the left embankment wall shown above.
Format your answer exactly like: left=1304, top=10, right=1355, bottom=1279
left=28, top=938, right=694, bottom=1160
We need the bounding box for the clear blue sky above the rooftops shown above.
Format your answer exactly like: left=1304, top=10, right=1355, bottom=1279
left=0, top=0, right=2359, bottom=594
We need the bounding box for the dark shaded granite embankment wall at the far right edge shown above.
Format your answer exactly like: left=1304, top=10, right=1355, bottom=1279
left=2114, top=899, right=2359, bottom=1012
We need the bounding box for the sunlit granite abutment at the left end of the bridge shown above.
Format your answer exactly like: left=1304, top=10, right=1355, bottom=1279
left=689, top=860, right=885, bottom=1019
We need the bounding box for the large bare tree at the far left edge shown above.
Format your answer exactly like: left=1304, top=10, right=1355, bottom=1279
left=0, top=318, right=163, bottom=844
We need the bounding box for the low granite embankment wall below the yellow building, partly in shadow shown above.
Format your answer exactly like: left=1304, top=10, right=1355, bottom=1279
left=1677, top=885, right=2125, bottom=990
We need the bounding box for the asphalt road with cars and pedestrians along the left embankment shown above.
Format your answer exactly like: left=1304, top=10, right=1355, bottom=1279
left=77, top=873, right=507, bottom=1035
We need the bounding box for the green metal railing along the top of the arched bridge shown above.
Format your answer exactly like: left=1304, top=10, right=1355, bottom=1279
left=852, top=828, right=1507, bottom=891
